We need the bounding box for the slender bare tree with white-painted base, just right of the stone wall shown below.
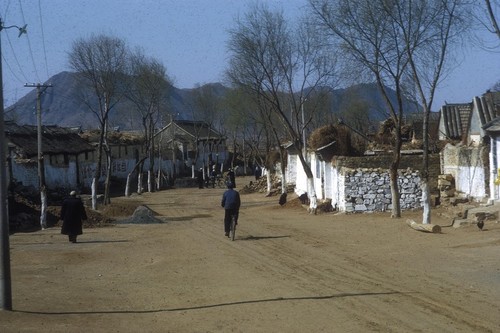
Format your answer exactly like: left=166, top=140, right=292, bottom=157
left=385, top=0, right=468, bottom=224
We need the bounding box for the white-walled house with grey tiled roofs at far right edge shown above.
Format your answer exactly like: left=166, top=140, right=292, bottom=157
left=439, top=92, right=500, bottom=201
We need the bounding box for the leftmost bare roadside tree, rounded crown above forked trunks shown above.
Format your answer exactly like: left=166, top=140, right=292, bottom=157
left=69, top=35, right=128, bottom=209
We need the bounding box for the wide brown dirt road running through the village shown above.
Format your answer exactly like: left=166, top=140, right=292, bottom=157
left=0, top=175, right=500, bottom=332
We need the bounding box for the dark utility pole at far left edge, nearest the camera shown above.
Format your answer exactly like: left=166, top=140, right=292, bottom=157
left=0, top=18, right=26, bottom=311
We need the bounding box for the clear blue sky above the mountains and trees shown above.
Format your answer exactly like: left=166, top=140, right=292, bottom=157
left=0, top=0, right=500, bottom=110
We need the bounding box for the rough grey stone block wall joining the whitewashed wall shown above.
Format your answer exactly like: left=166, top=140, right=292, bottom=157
left=341, top=168, right=422, bottom=213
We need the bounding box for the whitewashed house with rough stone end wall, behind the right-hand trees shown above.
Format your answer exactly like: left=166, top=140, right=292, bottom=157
left=285, top=116, right=441, bottom=212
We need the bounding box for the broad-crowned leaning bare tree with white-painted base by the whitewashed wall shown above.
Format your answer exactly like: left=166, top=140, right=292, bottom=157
left=228, top=5, right=332, bottom=213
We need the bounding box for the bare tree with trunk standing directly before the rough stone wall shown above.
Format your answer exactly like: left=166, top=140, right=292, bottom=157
left=310, top=0, right=408, bottom=217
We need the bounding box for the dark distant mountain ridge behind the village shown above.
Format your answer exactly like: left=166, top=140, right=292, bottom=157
left=5, top=72, right=416, bottom=130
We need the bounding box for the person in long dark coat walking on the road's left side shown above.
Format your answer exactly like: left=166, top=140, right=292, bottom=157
left=61, top=191, right=87, bottom=243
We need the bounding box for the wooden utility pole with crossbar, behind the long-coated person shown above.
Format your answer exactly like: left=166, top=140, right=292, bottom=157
left=24, top=83, right=52, bottom=230
